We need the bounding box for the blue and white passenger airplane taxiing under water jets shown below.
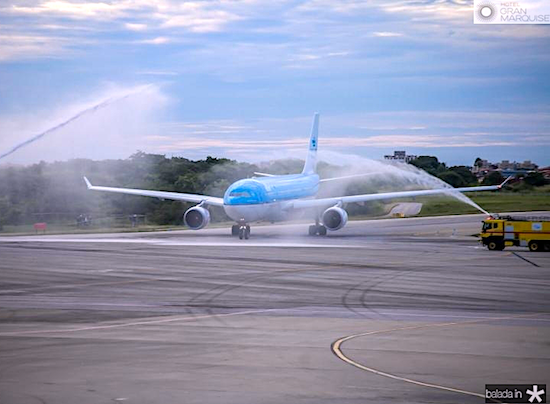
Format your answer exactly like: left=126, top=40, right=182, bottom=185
left=84, top=113, right=511, bottom=240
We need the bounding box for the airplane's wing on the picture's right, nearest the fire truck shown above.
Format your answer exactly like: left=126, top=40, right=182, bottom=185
left=287, top=177, right=511, bottom=213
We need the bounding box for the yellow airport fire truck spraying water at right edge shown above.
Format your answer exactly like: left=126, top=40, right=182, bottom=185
left=480, top=216, right=550, bottom=251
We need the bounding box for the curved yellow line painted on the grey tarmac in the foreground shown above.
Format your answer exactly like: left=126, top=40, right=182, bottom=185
left=331, top=313, right=548, bottom=403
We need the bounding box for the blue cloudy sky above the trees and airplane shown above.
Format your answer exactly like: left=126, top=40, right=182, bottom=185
left=0, top=0, right=550, bottom=166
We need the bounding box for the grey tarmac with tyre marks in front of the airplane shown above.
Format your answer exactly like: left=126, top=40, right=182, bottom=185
left=0, top=213, right=550, bottom=404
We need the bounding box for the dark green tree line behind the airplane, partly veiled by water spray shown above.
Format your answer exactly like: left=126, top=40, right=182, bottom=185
left=0, top=152, right=548, bottom=226
